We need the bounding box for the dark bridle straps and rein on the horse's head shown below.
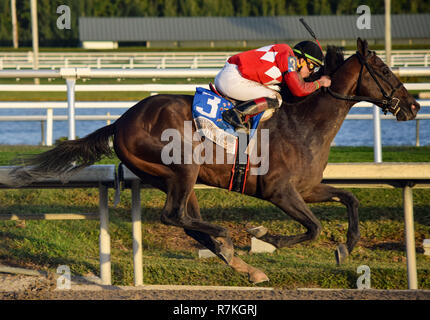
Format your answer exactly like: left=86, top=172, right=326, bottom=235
left=327, top=51, right=402, bottom=115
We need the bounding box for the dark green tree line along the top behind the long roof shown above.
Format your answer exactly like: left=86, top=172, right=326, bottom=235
left=0, top=0, right=430, bottom=46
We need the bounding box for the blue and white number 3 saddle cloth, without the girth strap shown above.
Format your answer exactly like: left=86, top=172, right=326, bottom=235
left=192, top=87, right=264, bottom=154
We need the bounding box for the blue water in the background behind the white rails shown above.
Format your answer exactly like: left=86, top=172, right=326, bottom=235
left=0, top=107, right=430, bottom=146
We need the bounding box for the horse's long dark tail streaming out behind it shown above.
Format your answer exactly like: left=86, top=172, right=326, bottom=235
left=9, top=123, right=115, bottom=186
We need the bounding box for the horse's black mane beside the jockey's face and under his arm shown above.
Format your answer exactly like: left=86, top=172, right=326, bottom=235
left=281, top=45, right=345, bottom=104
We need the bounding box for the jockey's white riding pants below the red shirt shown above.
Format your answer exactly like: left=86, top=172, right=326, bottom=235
left=215, top=62, right=282, bottom=105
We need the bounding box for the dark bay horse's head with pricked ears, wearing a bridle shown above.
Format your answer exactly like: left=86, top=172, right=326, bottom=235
left=355, top=38, right=420, bottom=121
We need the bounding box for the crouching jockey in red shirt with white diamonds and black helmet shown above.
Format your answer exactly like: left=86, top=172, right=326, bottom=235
left=215, top=41, right=331, bottom=130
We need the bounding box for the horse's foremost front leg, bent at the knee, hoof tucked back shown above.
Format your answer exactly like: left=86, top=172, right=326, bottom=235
left=305, top=184, right=360, bottom=264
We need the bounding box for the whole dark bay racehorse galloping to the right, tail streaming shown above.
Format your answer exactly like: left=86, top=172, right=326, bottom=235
left=9, top=39, right=420, bottom=283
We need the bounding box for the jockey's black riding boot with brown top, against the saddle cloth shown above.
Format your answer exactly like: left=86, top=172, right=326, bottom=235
left=222, top=97, right=279, bottom=131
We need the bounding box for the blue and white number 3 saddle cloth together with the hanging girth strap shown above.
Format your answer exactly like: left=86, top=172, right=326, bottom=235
left=192, top=87, right=264, bottom=193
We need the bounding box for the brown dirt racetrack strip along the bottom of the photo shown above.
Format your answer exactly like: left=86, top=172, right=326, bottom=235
left=0, top=273, right=430, bottom=301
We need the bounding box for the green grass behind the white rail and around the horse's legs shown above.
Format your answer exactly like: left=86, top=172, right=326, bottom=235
left=0, top=146, right=430, bottom=289
